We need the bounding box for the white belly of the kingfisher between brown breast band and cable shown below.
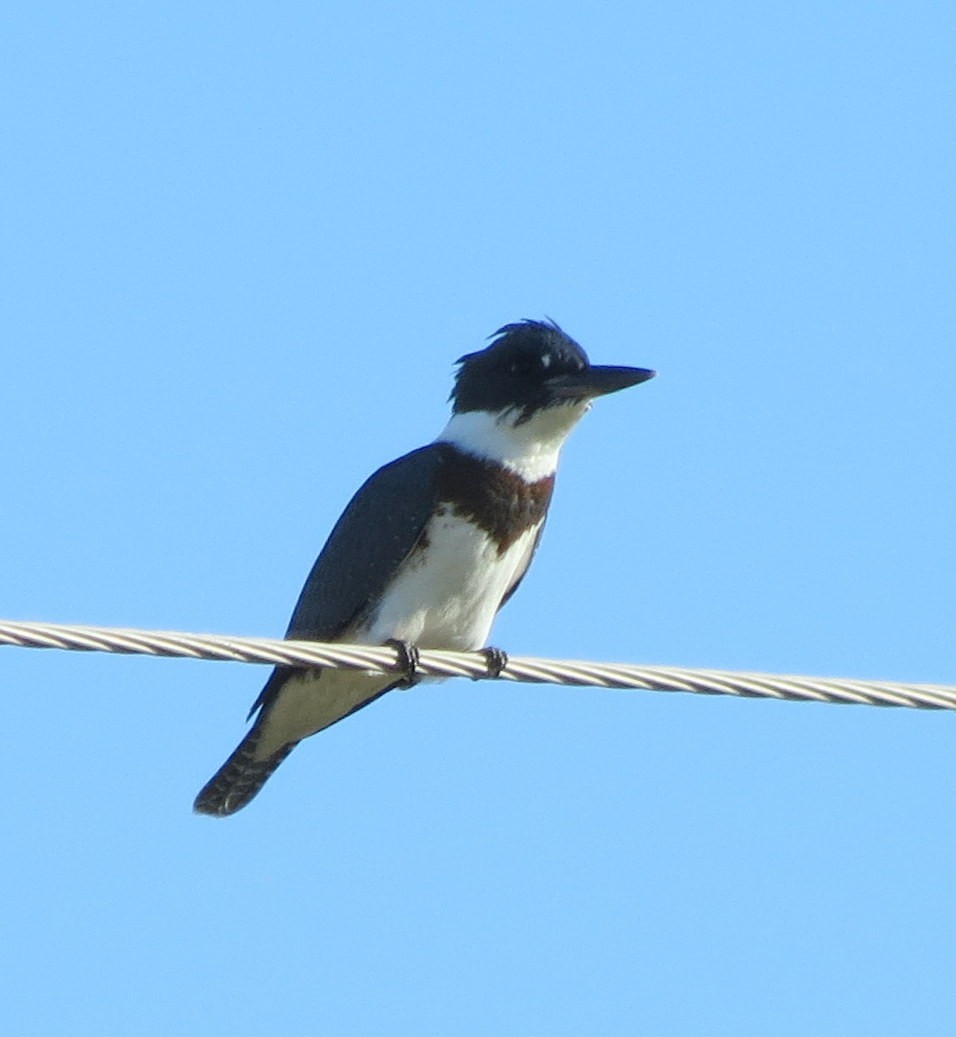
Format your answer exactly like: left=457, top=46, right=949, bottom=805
left=360, top=506, right=538, bottom=651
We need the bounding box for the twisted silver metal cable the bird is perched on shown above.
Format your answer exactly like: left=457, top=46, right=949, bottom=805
left=0, top=621, right=956, bottom=709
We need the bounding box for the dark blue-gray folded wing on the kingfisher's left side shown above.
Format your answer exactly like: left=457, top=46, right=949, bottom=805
left=286, top=443, right=447, bottom=641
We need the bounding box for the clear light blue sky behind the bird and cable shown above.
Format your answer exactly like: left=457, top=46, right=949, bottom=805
left=0, top=0, right=956, bottom=1037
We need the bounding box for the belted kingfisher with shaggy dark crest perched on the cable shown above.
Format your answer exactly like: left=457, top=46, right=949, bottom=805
left=194, top=320, right=654, bottom=816
